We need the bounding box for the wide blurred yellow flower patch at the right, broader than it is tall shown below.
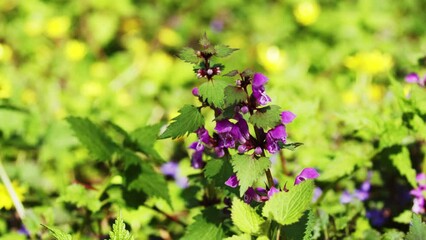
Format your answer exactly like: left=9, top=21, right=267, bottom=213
left=344, top=51, right=393, bottom=75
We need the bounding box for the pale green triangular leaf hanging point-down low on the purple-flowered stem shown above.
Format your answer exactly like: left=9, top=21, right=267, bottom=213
left=232, top=154, right=271, bottom=197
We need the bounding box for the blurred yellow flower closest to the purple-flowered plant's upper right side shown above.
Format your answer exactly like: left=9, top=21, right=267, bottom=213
left=257, top=44, right=287, bottom=73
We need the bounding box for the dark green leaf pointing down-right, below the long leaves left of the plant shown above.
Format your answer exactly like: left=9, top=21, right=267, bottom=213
left=123, top=152, right=171, bottom=206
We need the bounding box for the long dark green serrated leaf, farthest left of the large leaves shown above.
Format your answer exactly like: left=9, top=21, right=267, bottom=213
left=67, top=117, right=119, bottom=160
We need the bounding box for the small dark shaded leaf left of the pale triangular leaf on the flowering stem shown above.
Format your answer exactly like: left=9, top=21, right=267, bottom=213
left=204, top=159, right=232, bottom=187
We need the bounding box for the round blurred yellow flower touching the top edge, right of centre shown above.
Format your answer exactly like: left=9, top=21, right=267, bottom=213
left=293, top=1, right=321, bottom=26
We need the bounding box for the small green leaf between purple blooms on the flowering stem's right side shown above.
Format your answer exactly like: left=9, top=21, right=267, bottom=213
left=249, top=105, right=281, bottom=129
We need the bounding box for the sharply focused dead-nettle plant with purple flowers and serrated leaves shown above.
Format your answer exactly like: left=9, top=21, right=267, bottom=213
left=160, top=36, right=319, bottom=203
